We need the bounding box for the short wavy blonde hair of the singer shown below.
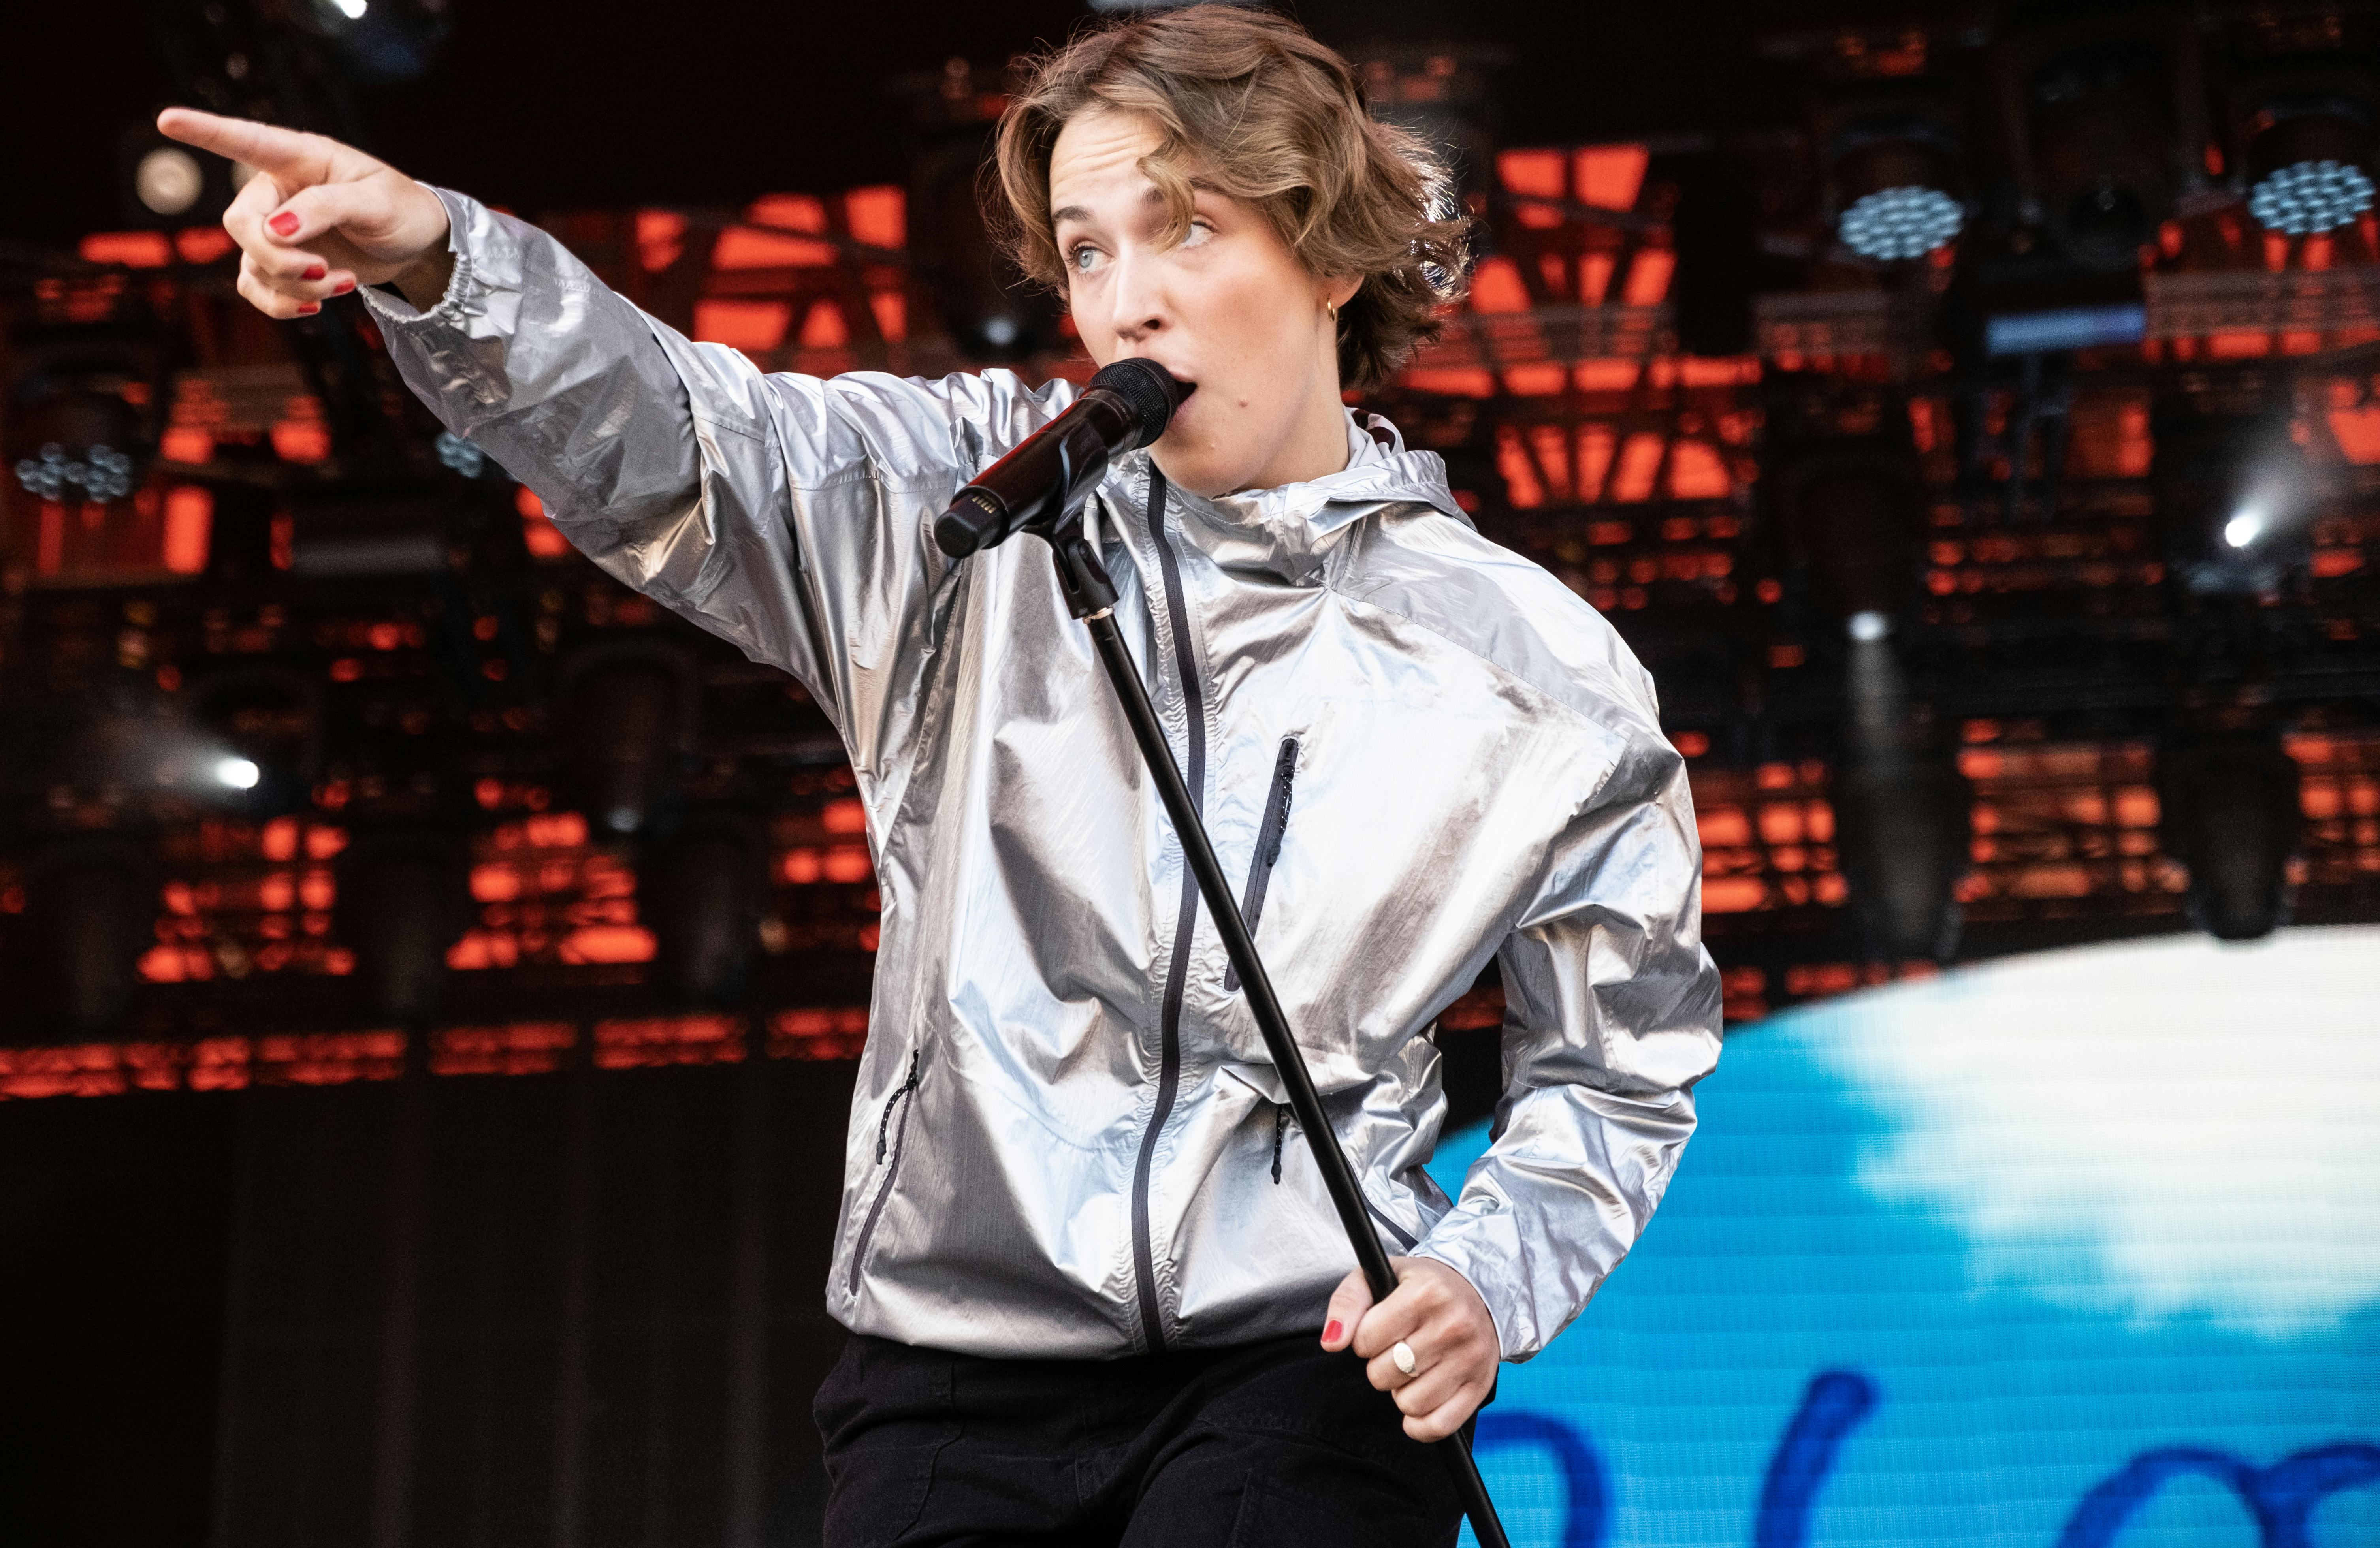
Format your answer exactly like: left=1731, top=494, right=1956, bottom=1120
left=995, top=5, right=1469, bottom=390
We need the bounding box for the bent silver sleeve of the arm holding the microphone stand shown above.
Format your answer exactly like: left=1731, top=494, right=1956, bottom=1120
left=1414, top=730, right=1721, bottom=1360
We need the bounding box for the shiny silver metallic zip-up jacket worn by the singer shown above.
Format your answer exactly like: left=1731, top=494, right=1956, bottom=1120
left=367, top=193, right=1718, bottom=1360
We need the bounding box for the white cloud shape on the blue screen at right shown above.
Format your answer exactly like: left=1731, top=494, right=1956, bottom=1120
left=1778, top=925, right=2380, bottom=1339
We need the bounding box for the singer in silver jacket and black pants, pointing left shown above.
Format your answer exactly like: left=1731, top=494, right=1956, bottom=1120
left=160, top=7, right=1718, bottom=1548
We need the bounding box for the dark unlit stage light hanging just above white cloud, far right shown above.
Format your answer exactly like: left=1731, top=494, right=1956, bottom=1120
left=2156, top=732, right=2299, bottom=942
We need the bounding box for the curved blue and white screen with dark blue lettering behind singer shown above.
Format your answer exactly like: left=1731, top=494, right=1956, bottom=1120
left=1430, top=927, right=2380, bottom=1548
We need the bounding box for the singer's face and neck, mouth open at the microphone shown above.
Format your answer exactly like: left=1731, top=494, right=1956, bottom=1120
left=1050, top=109, right=1354, bottom=497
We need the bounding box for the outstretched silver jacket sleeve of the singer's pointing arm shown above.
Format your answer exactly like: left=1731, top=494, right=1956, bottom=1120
left=364, top=188, right=1071, bottom=768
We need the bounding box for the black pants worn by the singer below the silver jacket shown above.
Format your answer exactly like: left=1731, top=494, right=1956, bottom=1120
left=816, top=1334, right=1461, bottom=1548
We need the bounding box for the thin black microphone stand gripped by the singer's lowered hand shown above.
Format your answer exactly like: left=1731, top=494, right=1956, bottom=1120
left=1023, top=495, right=1511, bottom=1548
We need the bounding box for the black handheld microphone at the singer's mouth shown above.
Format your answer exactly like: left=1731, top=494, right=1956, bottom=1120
left=933, top=357, right=1195, bottom=559
